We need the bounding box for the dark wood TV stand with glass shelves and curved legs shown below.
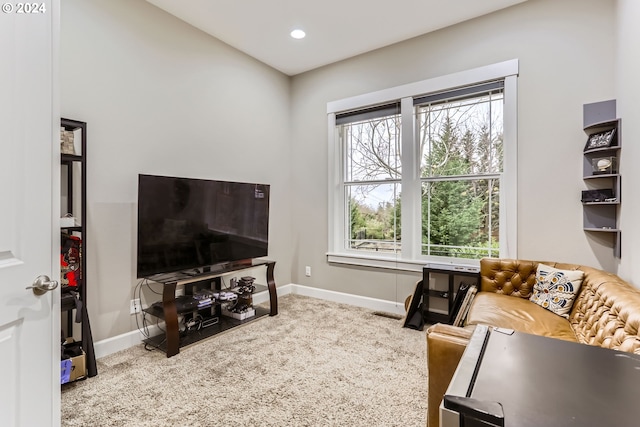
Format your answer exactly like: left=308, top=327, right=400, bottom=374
left=144, top=260, right=278, bottom=357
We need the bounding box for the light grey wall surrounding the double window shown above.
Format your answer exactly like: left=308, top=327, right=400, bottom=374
left=292, top=0, right=625, bottom=301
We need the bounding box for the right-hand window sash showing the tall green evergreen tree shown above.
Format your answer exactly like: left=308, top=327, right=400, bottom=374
left=415, top=81, right=504, bottom=259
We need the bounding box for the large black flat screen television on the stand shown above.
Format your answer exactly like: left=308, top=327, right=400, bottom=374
left=137, top=175, right=269, bottom=278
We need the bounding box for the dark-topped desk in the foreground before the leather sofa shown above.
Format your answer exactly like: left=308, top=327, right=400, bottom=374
left=440, top=327, right=640, bottom=427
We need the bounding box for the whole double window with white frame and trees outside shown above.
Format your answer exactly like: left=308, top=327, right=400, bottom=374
left=327, top=60, right=518, bottom=270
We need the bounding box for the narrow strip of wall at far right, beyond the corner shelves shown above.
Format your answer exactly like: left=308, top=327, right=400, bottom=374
left=616, top=0, right=640, bottom=286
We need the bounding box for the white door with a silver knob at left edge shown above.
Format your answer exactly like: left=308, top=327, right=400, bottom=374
left=0, top=0, right=60, bottom=427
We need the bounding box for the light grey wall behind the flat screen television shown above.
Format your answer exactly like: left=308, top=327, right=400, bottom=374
left=60, top=0, right=292, bottom=341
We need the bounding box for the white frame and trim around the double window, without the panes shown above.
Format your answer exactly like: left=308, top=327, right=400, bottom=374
left=327, top=59, right=519, bottom=271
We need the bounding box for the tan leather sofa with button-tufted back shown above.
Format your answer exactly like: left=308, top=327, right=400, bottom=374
left=427, top=258, right=640, bottom=427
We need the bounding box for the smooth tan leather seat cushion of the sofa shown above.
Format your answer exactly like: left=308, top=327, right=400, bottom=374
left=465, top=292, right=577, bottom=341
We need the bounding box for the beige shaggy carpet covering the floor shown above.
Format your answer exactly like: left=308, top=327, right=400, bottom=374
left=62, top=295, right=427, bottom=427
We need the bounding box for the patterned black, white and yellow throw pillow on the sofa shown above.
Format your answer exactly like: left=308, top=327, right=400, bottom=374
left=529, top=264, right=584, bottom=318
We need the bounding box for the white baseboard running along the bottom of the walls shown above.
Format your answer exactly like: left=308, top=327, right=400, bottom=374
left=94, top=283, right=405, bottom=359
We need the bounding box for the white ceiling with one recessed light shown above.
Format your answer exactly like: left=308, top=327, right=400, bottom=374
left=147, top=0, right=526, bottom=76
